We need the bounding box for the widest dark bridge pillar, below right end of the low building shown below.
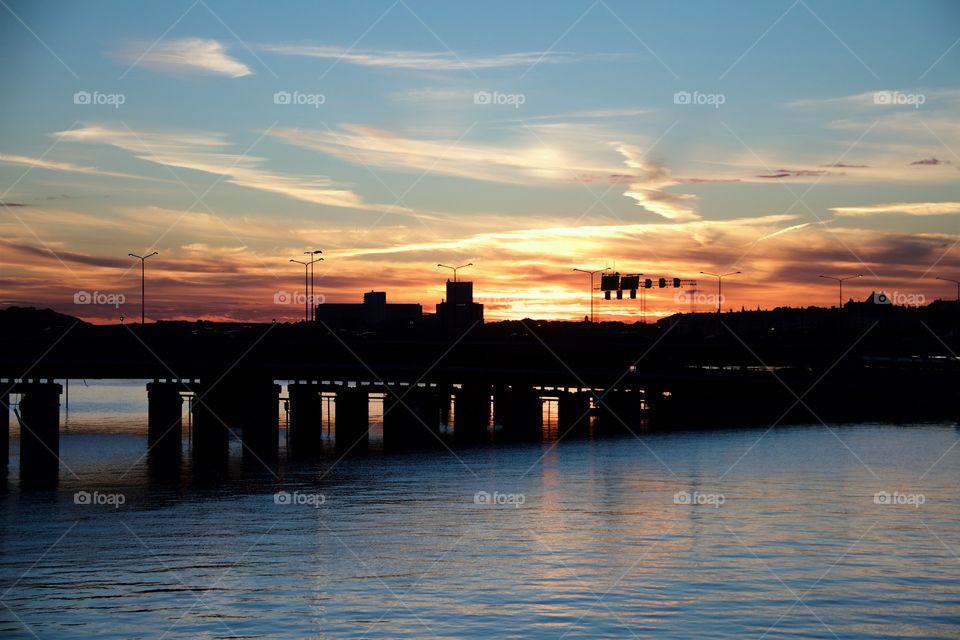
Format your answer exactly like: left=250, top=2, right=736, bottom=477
left=383, top=387, right=440, bottom=446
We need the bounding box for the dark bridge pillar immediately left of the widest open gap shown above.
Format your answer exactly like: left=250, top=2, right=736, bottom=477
left=17, top=382, right=63, bottom=486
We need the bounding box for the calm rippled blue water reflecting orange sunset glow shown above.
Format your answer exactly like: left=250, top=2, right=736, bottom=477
left=0, top=382, right=960, bottom=638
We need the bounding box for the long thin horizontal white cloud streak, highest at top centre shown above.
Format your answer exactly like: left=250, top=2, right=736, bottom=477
left=256, top=44, right=596, bottom=71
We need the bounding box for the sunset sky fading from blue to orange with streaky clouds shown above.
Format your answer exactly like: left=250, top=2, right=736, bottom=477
left=0, top=0, right=960, bottom=322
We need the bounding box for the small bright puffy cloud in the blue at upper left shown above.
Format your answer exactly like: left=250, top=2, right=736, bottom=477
left=114, top=38, right=253, bottom=78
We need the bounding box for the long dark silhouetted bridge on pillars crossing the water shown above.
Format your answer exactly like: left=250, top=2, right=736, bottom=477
left=0, top=310, right=960, bottom=480
